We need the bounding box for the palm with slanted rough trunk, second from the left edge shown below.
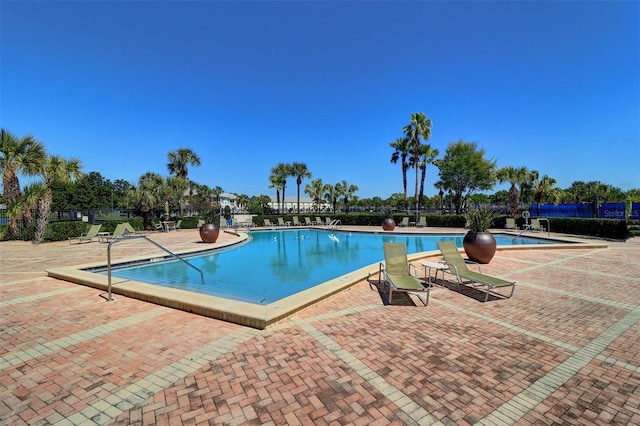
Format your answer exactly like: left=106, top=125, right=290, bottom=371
left=33, top=155, right=82, bottom=244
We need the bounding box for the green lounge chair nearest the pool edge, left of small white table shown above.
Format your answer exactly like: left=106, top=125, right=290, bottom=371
left=378, top=243, right=431, bottom=306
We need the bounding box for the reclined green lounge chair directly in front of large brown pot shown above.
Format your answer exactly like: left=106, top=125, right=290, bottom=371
left=438, top=241, right=516, bottom=302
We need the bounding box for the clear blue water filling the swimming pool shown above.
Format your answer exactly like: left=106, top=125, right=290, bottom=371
left=105, top=229, right=553, bottom=305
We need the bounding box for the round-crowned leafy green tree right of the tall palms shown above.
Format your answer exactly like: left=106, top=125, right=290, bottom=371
left=436, top=139, right=496, bottom=214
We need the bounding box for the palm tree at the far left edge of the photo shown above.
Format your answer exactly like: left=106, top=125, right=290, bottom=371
left=0, top=129, right=45, bottom=237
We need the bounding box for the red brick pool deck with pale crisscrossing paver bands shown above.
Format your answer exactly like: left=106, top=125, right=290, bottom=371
left=0, top=228, right=640, bottom=425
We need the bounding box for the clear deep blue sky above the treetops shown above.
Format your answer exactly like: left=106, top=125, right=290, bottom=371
left=0, top=1, right=640, bottom=198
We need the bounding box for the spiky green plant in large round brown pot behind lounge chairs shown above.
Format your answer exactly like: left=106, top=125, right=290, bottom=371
left=462, top=207, right=497, bottom=264
